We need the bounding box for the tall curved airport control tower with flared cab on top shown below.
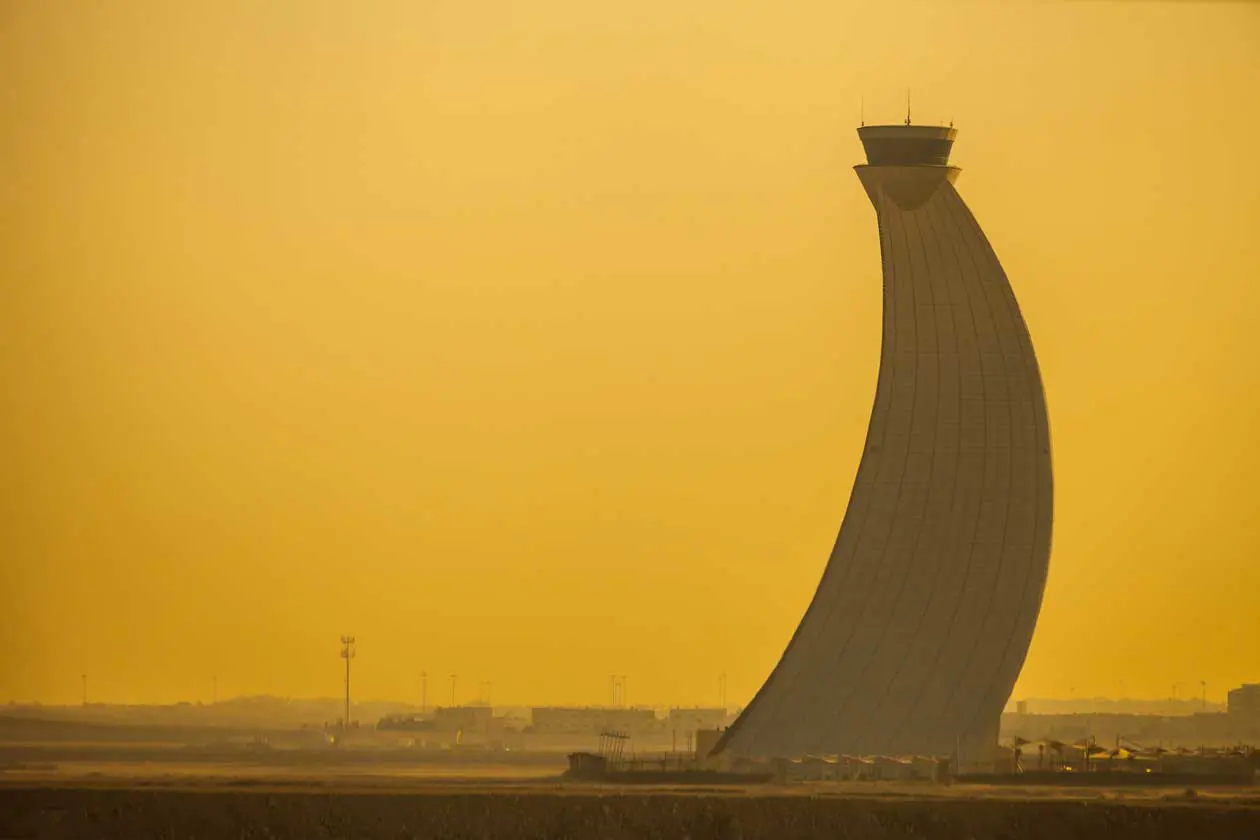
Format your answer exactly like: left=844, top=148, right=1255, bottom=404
left=714, top=125, right=1053, bottom=759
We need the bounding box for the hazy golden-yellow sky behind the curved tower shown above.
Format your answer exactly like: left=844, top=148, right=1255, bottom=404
left=0, top=0, right=1260, bottom=703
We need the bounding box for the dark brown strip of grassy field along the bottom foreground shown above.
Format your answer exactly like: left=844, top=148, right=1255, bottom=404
left=0, top=777, right=1260, bottom=840
